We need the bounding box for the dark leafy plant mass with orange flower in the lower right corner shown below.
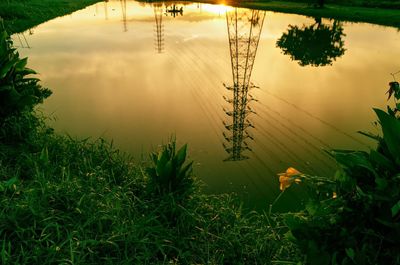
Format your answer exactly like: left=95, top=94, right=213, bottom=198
left=281, top=79, right=400, bottom=264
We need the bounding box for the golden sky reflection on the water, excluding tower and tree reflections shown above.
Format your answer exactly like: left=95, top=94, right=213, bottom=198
left=14, top=1, right=400, bottom=210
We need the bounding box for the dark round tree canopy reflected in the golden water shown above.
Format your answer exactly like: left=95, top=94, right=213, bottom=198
left=276, top=19, right=345, bottom=66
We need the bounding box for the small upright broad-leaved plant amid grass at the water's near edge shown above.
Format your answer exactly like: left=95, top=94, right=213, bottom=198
left=147, top=140, right=193, bottom=194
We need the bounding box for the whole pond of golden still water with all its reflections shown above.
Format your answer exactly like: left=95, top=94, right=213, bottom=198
left=13, top=0, right=400, bottom=210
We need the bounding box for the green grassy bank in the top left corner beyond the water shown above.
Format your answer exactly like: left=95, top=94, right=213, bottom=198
left=0, top=0, right=100, bottom=33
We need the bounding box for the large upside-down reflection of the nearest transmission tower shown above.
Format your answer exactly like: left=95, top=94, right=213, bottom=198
left=224, top=8, right=265, bottom=161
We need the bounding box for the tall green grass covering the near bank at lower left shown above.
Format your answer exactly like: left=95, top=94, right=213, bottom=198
left=0, top=126, right=300, bottom=264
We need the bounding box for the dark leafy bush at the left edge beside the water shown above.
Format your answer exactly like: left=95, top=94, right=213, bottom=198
left=0, top=21, right=51, bottom=124
